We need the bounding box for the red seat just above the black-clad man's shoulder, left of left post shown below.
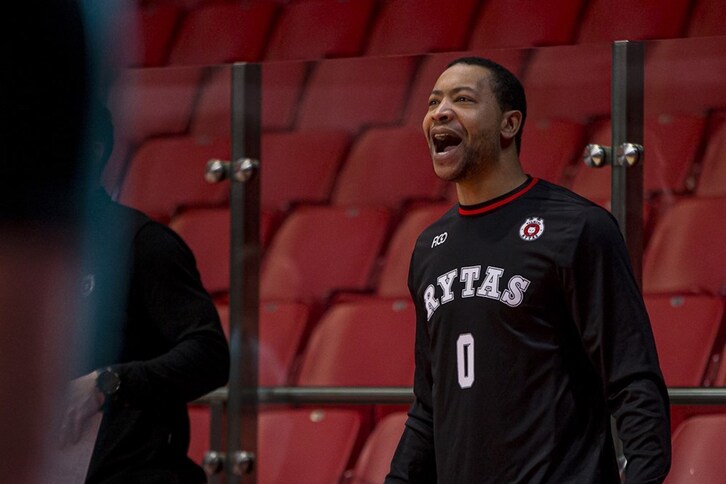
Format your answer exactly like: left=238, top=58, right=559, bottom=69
left=119, top=136, right=229, bottom=221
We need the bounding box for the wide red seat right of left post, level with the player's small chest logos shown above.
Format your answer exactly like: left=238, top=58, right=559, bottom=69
left=260, top=206, right=390, bottom=303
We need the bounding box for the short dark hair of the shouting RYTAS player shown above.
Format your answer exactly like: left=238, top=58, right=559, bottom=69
left=446, top=56, right=527, bottom=153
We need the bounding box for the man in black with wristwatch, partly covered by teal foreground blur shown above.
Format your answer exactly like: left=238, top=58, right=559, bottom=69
left=61, top=104, right=229, bottom=484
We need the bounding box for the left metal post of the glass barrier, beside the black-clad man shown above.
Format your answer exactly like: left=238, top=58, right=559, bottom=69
left=225, top=63, right=261, bottom=484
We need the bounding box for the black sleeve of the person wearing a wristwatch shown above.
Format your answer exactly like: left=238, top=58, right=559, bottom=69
left=108, top=223, right=229, bottom=405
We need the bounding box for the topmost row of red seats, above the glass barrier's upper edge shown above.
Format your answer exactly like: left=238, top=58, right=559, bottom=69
left=129, top=0, right=726, bottom=66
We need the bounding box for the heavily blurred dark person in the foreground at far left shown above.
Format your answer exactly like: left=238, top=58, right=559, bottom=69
left=0, top=0, right=88, bottom=484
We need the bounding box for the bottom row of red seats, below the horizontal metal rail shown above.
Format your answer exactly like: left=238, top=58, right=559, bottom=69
left=189, top=407, right=726, bottom=484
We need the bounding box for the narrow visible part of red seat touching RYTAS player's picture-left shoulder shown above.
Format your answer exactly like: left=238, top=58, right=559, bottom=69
left=376, top=202, right=452, bottom=298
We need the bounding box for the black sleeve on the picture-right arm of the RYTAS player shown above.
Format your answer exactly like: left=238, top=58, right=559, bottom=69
left=563, top=207, right=671, bottom=483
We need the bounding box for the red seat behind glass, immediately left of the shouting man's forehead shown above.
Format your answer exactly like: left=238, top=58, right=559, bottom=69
left=297, top=57, right=415, bottom=132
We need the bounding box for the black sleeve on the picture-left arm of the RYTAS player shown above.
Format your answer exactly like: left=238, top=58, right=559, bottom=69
left=385, top=248, right=436, bottom=484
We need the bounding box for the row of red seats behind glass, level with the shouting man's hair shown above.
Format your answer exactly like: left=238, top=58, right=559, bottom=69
left=109, top=37, right=726, bottom=145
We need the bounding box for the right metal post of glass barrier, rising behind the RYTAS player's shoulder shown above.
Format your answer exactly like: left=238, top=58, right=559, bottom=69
left=611, top=41, right=644, bottom=287
